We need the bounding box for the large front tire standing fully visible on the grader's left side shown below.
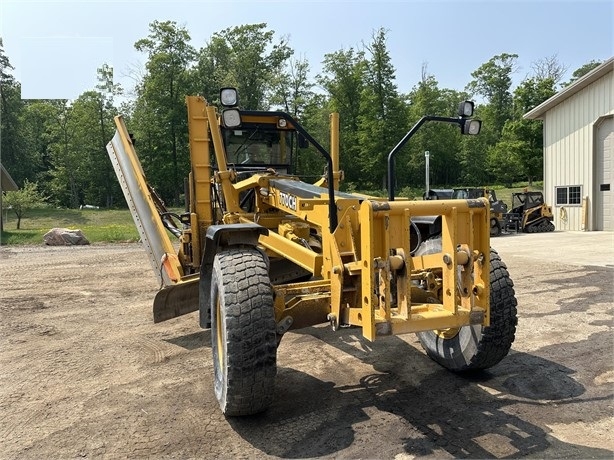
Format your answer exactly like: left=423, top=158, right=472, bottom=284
left=211, top=248, right=277, bottom=416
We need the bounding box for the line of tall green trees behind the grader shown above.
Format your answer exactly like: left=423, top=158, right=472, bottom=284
left=0, top=21, right=568, bottom=209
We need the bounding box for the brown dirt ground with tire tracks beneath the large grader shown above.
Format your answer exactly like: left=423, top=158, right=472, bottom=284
left=0, top=232, right=614, bottom=459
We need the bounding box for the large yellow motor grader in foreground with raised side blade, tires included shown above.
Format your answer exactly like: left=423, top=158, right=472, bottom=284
left=107, top=88, right=516, bottom=416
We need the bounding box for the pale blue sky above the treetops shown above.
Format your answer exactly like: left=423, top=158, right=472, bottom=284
left=0, top=0, right=614, bottom=99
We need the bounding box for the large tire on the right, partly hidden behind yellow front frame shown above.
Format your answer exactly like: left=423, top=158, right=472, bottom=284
left=418, top=249, right=518, bottom=372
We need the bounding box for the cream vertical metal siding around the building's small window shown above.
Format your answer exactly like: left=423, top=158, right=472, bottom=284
left=544, top=72, right=614, bottom=230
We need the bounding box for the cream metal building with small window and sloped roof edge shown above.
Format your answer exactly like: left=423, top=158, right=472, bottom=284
left=524, top=57, right=614, bottom=231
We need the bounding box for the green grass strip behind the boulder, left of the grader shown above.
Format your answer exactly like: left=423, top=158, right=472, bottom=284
left=0, top=208, right=140, bottom=245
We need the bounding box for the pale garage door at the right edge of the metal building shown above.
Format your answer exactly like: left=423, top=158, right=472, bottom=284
left=594, top=117, right=614, bottom=230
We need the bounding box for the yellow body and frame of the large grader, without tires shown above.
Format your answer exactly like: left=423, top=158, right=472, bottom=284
left=109, top=96, right=490, bottom=340
